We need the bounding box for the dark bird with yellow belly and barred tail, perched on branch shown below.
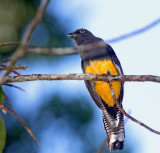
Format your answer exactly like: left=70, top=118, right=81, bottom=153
left=67, top=28, right=125, bottom=152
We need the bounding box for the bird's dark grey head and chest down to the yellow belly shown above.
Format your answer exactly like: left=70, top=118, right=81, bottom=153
left=67, top=29, right=107, bottom=60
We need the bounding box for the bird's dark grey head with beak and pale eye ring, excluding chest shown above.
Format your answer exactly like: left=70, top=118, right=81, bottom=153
left=67, top=28, right=102, bottom=46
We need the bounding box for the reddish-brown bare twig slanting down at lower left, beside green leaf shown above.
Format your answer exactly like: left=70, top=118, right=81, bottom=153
left=0, top=104, right=39, bottom=147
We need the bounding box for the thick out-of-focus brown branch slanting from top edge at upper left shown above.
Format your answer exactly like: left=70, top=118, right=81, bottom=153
left=0, top=0, right=50, bottom=84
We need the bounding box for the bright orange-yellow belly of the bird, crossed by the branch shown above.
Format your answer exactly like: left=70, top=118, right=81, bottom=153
left=85, top=60, right=121, bottom=107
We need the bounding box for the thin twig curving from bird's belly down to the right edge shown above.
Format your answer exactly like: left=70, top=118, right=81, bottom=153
left=109, top=81, right=160, bottom=135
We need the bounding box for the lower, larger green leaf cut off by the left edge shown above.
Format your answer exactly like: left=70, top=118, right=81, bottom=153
left=0, top=117, right=6, bottom=153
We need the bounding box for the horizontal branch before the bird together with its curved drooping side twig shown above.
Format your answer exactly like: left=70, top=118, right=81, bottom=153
left=0, top=74, right=160, bottom=135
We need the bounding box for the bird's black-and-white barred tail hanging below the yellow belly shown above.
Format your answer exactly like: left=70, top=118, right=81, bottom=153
left=103, top=110, right=125, bottom=152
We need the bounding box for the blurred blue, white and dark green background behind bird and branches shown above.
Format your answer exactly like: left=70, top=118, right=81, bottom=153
left=0, top=0, right=160, bottom=153
